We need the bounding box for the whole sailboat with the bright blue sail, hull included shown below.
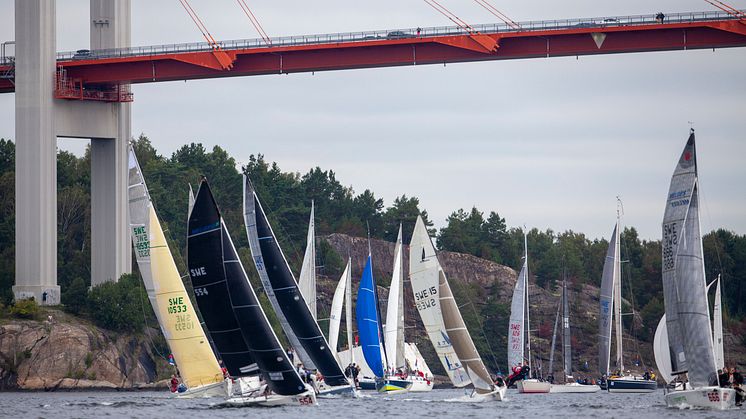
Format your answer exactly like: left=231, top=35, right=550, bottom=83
left=355, top=252, right=412, bottom=393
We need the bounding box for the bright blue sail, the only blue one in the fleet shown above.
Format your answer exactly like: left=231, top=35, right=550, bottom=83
left=355, top=255, right=383, bottom=377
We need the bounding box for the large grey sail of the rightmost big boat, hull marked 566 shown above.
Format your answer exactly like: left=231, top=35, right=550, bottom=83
left=662, top=131, right=717, bottom=387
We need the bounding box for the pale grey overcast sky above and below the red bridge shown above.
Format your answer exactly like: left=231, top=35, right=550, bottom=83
left=0, top=0, right=746, bottom=239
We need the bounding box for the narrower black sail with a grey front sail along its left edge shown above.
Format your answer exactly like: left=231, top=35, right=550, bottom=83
left=244, top=177, right=349, bottom=386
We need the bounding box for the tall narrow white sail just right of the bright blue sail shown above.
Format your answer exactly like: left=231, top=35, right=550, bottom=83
left=385, top=224, right=405, bottom=371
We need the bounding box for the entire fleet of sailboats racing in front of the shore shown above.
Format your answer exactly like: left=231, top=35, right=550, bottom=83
left=129, top=131, right=736, bottom=409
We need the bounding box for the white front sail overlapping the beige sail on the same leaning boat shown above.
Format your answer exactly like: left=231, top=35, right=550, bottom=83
left=409, top=217, right=471, bottom=387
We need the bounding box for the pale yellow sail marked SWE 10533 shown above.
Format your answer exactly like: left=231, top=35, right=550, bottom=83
left=149, top=205, right=223, bottom=388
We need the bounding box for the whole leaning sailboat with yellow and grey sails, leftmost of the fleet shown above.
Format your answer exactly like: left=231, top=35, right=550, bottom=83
left=128, top=145, right=227, bottom=398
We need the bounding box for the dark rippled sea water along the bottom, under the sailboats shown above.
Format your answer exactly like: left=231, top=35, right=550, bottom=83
left=0, top=390, right=746, bottom=419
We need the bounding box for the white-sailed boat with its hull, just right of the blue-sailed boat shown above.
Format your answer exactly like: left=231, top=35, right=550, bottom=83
left=384, top=224, right=433, bottom=391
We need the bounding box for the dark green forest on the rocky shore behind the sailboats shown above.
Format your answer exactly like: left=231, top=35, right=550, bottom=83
left=0, top=135, right=746, bottom=356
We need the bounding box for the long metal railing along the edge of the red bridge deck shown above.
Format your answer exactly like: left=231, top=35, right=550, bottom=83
left=57, top=11, right=738, bottom=61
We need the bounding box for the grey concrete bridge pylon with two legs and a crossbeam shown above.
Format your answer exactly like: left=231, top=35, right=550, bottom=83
left=13, top=0, right=132, bottom=305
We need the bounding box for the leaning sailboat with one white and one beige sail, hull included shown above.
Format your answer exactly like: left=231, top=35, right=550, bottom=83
left=409, top=216, right=507, bottom=401
